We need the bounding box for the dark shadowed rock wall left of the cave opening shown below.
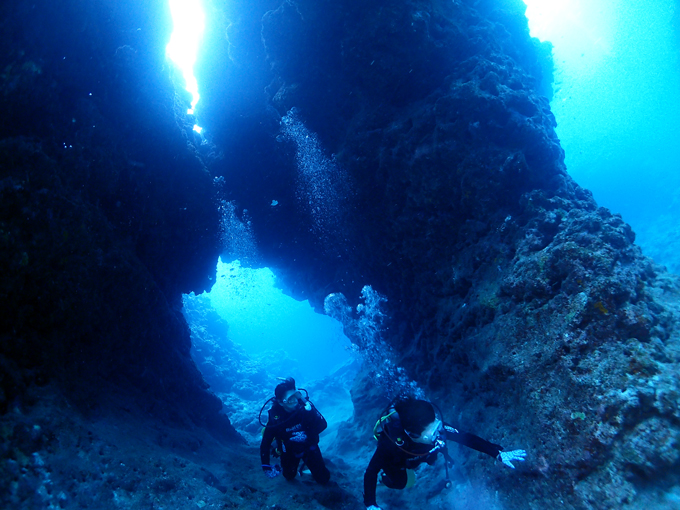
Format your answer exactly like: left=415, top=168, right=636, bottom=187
left=0, top=1, right=239, bottom=437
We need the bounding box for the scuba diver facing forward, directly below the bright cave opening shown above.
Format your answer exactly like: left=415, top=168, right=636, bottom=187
left=260, top=377, right=331, bottom=485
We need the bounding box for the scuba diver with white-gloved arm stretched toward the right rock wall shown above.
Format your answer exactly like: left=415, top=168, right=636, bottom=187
left=364, top=397, right=526, bottom=510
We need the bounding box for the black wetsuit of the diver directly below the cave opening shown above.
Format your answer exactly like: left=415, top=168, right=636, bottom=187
left=260, top=402, right=331, bottom=485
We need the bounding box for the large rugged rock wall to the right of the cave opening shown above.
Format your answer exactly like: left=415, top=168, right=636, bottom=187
left=212, top=0, right=680, bottom=508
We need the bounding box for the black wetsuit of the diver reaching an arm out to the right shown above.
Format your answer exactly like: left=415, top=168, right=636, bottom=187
left=364, top=419, right=503, bottom=507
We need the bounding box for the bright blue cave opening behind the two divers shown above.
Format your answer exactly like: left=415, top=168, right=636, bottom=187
left=184, top=259, right=361, bottom=443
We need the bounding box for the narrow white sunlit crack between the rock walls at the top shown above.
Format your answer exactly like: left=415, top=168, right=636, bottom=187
left=165, top=0, right=205, bottom=115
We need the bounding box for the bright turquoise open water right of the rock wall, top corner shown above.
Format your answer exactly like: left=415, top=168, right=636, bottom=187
left=526, top=0, right=680, bottom=272
